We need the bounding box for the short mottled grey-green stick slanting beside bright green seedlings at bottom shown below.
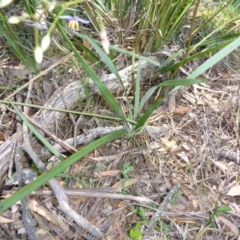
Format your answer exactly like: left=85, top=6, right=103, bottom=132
left=146, top=184, right=181, bottom=236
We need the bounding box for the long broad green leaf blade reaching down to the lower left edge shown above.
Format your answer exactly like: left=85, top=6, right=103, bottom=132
left=0, top=129, right=126, bottom=213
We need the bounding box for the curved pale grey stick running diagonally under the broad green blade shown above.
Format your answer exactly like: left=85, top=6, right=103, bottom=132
left=22, top=143, right=103, bottom=238
